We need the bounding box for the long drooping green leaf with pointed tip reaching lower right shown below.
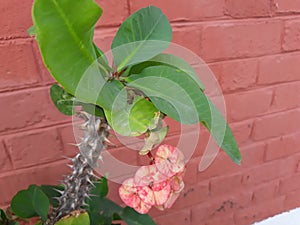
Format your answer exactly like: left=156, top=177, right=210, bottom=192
left=126, top=66, right=241, bottom=163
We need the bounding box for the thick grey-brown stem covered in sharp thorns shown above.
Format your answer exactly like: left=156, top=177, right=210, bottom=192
left=44, top=112, right=109, bottom=225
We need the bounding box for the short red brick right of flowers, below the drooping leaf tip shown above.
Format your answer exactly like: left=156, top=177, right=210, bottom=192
left=210, top=174, right=242, bottom=196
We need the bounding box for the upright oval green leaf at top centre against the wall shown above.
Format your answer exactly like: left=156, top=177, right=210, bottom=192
left=111, top=6, right=172, bottom=71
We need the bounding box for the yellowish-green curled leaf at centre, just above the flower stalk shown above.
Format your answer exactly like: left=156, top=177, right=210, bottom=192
left=104, top=96, right=158, bottom=136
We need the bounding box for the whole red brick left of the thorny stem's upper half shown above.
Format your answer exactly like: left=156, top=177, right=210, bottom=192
left=5, top=128, right=62, bottom=168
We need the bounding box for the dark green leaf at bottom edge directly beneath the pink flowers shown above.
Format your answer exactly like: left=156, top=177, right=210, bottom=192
left=120, top=207, right=156, bottom=225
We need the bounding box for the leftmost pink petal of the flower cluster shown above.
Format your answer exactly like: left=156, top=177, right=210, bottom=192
left=119, top=178, right=141, bottom=208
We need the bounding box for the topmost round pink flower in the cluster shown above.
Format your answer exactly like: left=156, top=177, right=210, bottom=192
left=155, top=145, right=185, bottom=178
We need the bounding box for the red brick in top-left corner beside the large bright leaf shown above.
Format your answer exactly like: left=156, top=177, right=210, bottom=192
left=0, top=0, right=32, bottom=38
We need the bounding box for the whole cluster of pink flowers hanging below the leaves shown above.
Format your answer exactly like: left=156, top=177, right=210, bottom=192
left=119, top=145, right=185, bottom=214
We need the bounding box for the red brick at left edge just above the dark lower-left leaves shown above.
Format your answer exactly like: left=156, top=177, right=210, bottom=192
left=0, top=160, right=70, bottom=205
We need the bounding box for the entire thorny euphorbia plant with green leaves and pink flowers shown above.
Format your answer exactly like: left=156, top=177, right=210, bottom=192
left=2, top=0, right=240, bottom=225
